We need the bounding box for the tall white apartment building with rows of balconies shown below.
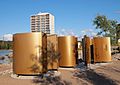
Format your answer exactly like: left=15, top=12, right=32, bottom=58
left=30, top=13, right=54, bottom=34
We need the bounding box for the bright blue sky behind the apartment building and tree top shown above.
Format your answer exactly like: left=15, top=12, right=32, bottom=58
left=0, top=0, right=120, bottom=36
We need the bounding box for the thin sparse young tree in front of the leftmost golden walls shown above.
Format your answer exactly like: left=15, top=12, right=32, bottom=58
left=30, top=42, right=60, bottom=73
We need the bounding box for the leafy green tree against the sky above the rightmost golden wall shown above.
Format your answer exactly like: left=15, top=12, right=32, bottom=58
left=93, top=15, right=117, bottom=44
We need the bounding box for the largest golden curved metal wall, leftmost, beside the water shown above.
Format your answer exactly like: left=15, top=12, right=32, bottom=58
left=13, top=32, right=47, bottom=75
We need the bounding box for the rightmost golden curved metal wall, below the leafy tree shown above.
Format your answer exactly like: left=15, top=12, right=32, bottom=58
left=93, top=37, right=111, bottom=62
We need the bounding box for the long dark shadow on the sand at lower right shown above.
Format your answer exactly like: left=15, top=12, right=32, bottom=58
left=74, top=69, right=117, bottom=85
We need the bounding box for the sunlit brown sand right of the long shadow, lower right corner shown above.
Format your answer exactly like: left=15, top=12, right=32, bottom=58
left=95, top=61, right=120, bottom=85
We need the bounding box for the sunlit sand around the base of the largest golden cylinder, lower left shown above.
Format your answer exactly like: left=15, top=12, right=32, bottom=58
left=0, top=64, right=36, bottom=85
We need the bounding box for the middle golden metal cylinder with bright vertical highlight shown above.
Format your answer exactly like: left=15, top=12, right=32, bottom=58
left=58, top=36, right=77, bottom=67
